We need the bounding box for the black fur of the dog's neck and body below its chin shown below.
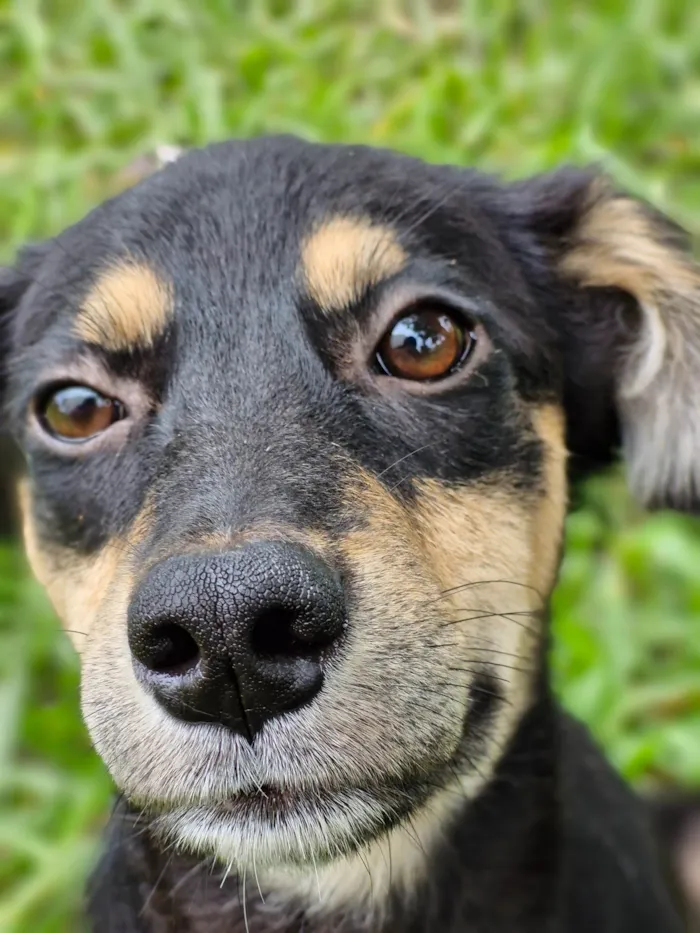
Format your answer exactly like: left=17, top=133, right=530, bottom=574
left=89, top=698, right=681, bottom=933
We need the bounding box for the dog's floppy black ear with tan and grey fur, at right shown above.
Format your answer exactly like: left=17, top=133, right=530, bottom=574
left=511, top=169, right=700, bottom=509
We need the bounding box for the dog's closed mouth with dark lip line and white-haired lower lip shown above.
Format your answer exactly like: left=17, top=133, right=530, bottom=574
left=142, top=668, right=498, bottom=866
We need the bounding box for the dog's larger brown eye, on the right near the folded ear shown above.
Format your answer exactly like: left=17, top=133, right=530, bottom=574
left=376, top=305, right=476, bottom=382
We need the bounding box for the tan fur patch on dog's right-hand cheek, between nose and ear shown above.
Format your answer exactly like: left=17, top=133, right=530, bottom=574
left=342, top=462, right=563, bottom=760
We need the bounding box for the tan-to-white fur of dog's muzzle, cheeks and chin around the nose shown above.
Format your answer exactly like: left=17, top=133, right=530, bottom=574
left=24, top=407, right=565, bottom=911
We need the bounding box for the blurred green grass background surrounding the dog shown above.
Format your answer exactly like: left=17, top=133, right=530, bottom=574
left=0, top=0, right=700, bottom=933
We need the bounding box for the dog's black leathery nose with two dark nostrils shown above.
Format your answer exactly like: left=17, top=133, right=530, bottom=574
left=129, top=542, right=345, bottom=741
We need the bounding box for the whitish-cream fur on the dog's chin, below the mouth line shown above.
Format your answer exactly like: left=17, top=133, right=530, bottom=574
left=150, top=778, right=474, bottom=914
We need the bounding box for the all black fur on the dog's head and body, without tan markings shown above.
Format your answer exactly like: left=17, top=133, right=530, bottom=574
left=0, top=138, right=680, bottom=933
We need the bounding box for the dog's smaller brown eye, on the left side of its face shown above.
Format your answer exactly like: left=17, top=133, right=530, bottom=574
left=38, top=386, right=126, bottom=441
